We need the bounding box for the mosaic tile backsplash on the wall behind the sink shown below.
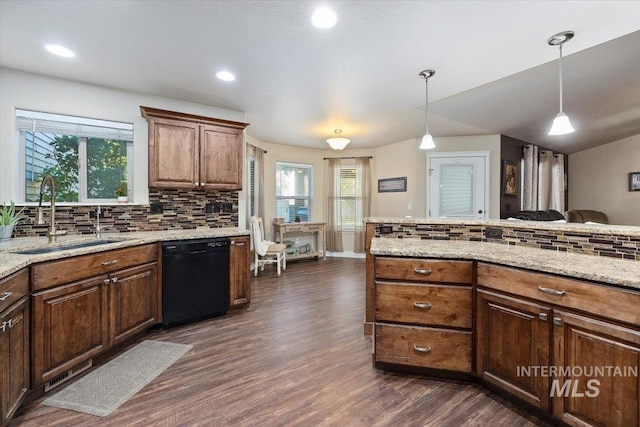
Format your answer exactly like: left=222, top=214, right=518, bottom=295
left=13, top=189, right=238, bottom=237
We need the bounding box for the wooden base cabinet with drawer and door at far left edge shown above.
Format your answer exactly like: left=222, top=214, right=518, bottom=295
left=0, top=269, right=30, bottom=426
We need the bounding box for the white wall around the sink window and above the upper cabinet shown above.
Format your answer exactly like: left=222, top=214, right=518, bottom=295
left=0, top=68, right=245, bottom=206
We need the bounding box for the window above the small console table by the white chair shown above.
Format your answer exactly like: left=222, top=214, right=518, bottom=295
left=276, top=162, right=313, bottom=222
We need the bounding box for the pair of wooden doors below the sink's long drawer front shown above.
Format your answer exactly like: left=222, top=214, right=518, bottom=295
left=32, top=251, right=159, bottom=387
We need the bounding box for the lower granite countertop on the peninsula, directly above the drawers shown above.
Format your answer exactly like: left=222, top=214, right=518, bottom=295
left=371, top=238, right=640, bottom=290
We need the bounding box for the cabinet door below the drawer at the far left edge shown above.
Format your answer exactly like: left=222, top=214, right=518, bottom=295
left=0, top=298, right=29, bottom=425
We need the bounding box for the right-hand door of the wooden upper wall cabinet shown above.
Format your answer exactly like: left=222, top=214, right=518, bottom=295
left=200, top=125, right=242, bottom=190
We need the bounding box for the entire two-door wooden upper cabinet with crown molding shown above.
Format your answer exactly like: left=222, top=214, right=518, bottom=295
left=140, top=107, right=247, bottom=190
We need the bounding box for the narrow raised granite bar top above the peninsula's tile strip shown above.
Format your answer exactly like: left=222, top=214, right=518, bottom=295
left=364, top=217, right=640, bottom=237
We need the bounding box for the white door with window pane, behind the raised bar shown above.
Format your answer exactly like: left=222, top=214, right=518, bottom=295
left=427, top=153, right=489, bottom=219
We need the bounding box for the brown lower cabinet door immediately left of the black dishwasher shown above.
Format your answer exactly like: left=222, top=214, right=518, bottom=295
left=108, top=263, right=159, bottom=346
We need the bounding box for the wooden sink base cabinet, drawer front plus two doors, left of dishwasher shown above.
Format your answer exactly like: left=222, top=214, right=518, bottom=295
left=32, top=244, right=160, bottom=387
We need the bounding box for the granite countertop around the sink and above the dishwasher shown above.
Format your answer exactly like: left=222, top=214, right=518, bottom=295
left=0, top=227, right=250, bottom=278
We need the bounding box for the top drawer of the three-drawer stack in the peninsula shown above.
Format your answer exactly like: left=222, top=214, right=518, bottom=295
left=375, top=257, right=473, bottom=284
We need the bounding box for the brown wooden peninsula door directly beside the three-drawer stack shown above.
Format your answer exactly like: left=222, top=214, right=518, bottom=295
left=476, top=290, right=551, bottom=410
